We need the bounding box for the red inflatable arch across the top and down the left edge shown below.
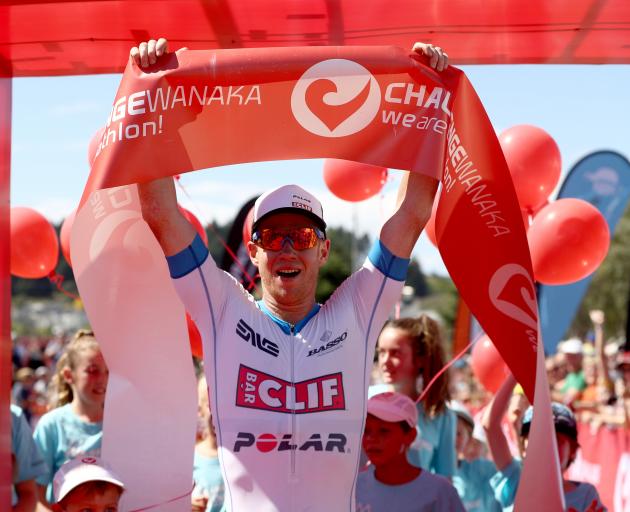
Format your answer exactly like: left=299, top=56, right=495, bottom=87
left=0, top=0, right=630, bottom=504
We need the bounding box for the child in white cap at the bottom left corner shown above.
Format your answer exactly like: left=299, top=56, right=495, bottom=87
left=53, top=456, right=125, bottom=512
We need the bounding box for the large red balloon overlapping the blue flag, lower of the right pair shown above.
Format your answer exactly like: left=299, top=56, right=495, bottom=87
left=527, top=198, right=610, bottom=284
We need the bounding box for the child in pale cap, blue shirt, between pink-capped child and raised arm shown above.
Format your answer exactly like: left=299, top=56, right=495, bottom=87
left=448, top=401, right=501, bottom=512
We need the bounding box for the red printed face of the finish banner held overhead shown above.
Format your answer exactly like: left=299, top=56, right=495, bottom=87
left=84, top=47, right=537, bottom=400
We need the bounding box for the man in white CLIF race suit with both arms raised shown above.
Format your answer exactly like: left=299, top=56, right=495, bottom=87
left=131, top=39, right=448, bottom=512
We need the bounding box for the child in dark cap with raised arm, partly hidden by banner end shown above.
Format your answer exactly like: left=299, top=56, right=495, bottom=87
left=483, top=375, right=606, bottom=512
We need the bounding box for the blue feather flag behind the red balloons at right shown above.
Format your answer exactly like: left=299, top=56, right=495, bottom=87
left=538, top=151, right=630, bottom=354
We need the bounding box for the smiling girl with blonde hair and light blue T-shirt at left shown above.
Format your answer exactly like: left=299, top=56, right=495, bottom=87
left=33, top=330, right=109, bottom=508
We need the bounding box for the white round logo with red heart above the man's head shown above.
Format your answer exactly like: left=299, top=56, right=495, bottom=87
left=291, top=59, right=381, bottom=137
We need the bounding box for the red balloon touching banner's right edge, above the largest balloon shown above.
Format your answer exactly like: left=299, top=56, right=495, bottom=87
left=499, top=124, right=562, bottom=212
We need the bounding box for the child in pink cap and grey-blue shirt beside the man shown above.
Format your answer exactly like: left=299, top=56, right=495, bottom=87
left=357, top=392, right=465, bottom=512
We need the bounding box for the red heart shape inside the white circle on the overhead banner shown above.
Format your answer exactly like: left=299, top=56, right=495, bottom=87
left=305, top=80, right=370, bottom=133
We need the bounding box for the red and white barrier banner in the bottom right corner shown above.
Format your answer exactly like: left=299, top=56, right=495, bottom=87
left=567, top=423, right=630, bottom=512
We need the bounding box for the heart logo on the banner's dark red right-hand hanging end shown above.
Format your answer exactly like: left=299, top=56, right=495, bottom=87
left=488, top=263, right=538, bottom=332
